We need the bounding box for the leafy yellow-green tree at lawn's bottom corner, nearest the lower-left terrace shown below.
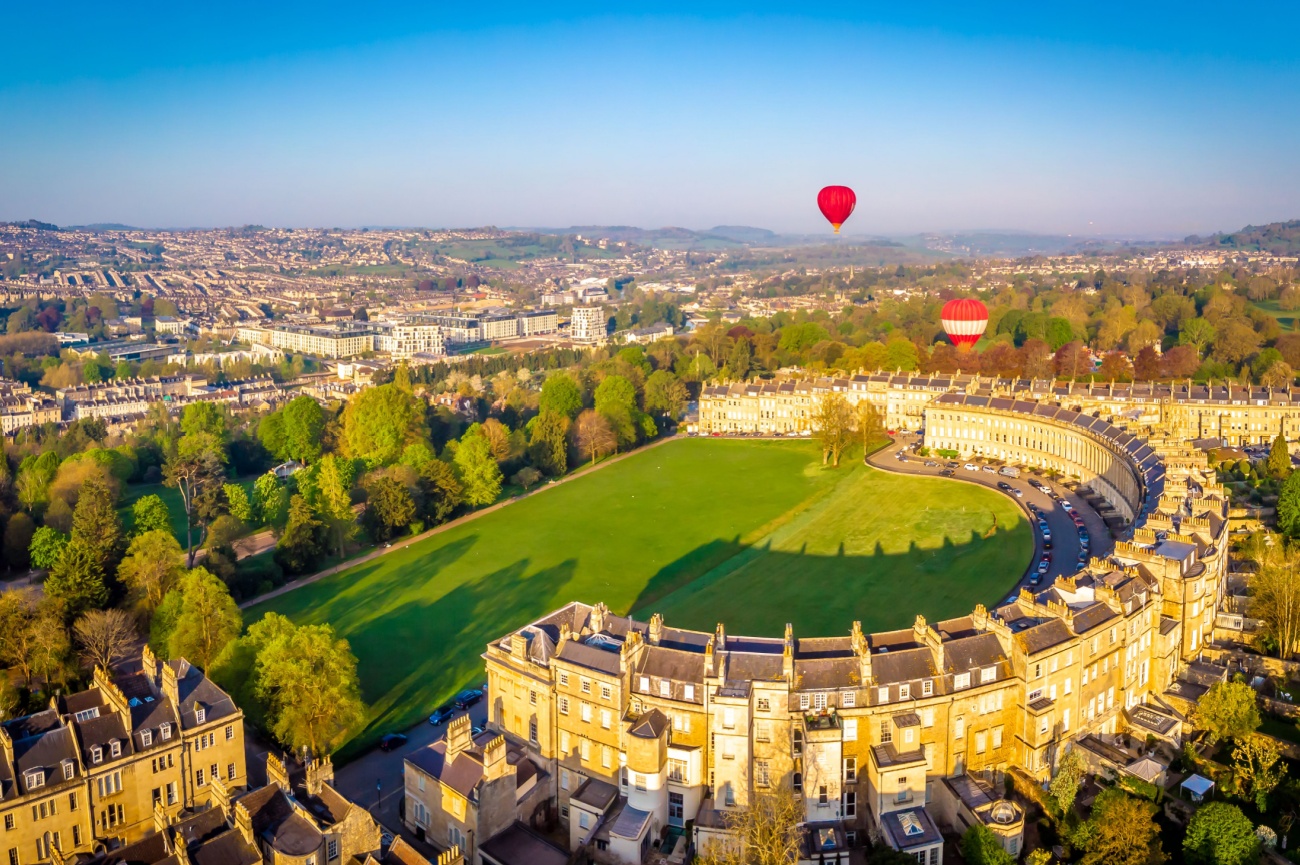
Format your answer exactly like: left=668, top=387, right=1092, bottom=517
left=250, top=613, right=365, bottom=754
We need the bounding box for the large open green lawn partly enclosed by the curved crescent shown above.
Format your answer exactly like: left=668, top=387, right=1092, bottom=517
left=246, top=440, right=1032, bottom=758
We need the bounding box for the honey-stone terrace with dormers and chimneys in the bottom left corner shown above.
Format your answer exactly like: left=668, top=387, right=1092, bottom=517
left=0, top=646, right=247, bottom=865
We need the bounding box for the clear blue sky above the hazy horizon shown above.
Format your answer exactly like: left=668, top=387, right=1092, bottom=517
left=0, top=0, right=1300, bottom=237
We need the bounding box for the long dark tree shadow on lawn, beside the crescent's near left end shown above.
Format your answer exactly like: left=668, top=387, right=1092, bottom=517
left=339, top=558, right=577, bottom=760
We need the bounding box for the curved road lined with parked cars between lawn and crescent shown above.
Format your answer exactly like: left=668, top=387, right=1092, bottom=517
left=867, top=432, right=1114, bottom=604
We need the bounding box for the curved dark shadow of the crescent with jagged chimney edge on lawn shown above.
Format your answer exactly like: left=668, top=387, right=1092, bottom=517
left=634, top=526, right=1034, bottom=636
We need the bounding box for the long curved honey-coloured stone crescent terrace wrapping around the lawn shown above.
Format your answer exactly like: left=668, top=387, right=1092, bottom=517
left=454, top=421, right=1227, bottom=865
